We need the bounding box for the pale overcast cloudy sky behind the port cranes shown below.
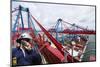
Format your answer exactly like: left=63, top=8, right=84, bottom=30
left=12, top=1, right=95, bottom=30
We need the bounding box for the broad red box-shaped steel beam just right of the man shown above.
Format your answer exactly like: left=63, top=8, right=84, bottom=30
left=40, top=42, right=64, bottom=64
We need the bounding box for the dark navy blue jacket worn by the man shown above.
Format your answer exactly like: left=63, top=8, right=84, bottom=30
left=12, top=48, right=42, bottom=66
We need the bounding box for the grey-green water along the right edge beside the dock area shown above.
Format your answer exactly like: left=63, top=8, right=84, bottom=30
left=82, top=35, right=96, bottom=62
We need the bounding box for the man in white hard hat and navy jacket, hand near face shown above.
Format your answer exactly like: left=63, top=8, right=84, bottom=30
left=12, top=33, right=42, bottom=66
